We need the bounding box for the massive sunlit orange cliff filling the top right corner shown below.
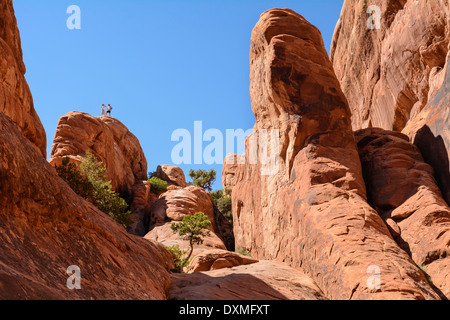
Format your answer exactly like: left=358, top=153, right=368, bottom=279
left=331, top=0, right=450, bottom=204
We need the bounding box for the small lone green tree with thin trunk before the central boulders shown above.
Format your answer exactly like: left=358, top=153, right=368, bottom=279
left=171, top=212, right=211, bottom=261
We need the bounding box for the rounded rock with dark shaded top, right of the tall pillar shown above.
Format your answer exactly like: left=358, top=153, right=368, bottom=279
left=356, top=129, right=450, bottom=297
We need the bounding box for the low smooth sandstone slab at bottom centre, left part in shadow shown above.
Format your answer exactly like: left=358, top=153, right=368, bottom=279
left=170, top=261, right=326, bottom=300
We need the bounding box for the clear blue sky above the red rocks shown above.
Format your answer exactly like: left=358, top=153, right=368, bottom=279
left=14, top=0, right=343, bottom=189
